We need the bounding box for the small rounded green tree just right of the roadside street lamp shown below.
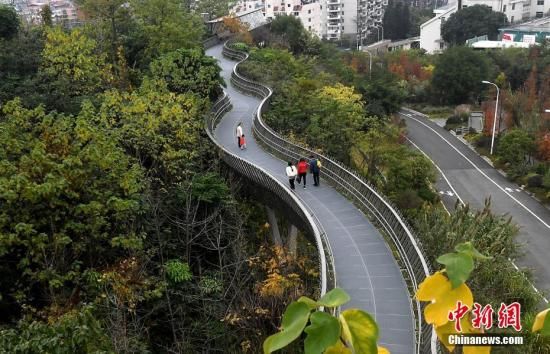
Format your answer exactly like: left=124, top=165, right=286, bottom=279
left=496, top=129, right=535, bottom=176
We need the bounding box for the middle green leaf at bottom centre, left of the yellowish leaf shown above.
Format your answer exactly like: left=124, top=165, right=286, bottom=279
left=304, top=311, right=340, bottom=354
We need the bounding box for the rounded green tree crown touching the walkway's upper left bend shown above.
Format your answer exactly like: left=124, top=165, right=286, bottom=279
left=151, top=49, right=225, bottom=100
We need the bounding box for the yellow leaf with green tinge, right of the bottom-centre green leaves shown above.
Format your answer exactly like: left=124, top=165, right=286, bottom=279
left=340, top=309, right=378, bottom=354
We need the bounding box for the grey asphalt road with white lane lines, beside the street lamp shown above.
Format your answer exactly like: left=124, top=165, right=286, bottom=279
left=400, top=110, right=550, bottom=292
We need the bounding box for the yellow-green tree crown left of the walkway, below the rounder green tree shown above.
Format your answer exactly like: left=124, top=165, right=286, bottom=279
left=98, top=81, right=205, bottom=181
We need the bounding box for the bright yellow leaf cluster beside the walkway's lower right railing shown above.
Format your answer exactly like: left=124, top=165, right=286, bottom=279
left=416, top=272, right=474, bottom=327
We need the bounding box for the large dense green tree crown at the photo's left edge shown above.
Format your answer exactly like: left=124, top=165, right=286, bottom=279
left=0, top=101, right=143, bottom=312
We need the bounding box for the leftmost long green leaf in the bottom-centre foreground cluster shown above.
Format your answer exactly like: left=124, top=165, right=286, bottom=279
left=264, top=302, right=310, bottom=353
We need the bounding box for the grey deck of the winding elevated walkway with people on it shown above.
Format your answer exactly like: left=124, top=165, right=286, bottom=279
left=206, top=45, right=414, bottom=354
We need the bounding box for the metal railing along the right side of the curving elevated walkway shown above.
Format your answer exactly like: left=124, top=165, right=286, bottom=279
left=223, top=42, right=437, bottom=353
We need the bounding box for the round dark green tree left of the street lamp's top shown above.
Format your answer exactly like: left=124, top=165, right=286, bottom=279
left=432, top=47, right=488, bottom=104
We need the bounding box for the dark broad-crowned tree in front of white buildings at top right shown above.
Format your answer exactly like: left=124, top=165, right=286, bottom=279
left=441, top=5, right=508, bottom=45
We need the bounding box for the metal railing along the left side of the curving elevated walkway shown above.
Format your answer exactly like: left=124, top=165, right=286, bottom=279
left=205, top=92, right=334, bottom=296
